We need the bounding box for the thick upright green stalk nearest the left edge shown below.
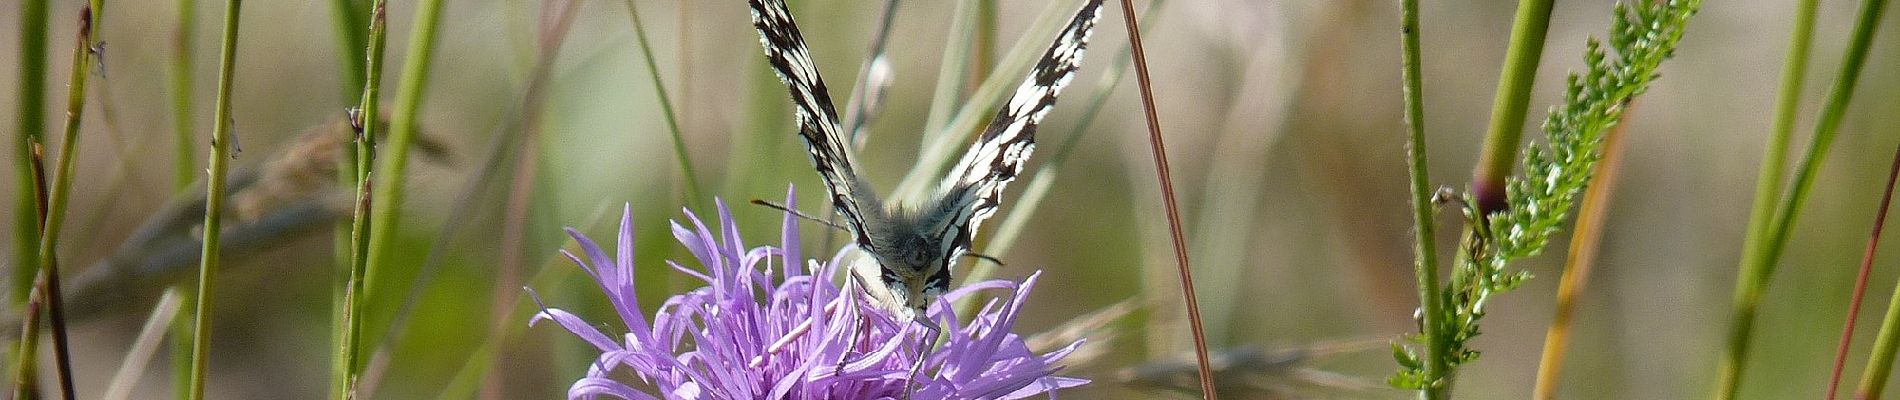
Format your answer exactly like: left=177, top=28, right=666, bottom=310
left=10, top=0, right=48, bottom=305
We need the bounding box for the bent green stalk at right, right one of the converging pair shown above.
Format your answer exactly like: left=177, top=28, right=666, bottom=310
left=1716, top=0, right=1887, bottom=400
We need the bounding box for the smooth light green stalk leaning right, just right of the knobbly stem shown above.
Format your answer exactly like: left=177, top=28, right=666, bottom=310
left=361, top=0, right=443, bottom=309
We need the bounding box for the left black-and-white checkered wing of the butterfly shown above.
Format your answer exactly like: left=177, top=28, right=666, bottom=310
left=749, top=0, right=882, bottom=246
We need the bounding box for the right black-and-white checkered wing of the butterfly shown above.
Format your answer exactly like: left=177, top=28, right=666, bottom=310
left=941, top=0, right=1102, bottom=256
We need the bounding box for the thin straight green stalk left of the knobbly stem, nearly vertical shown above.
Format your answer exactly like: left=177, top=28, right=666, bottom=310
left=186, top=0, right=243, bottom=400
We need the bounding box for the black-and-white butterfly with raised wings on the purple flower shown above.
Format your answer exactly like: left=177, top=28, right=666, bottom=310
left=749, top=0, right=1102, bottom=390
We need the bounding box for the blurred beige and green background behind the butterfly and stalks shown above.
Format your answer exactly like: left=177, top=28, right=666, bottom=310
left=0, top=0, right=1900, bottom=398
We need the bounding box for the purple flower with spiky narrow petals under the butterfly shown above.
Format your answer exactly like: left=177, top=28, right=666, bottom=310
left=530, top=188, right=1089, bottom=398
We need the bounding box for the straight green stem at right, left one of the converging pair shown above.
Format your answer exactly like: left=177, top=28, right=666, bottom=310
left=1716, top=0, right=1820, bottom=398
